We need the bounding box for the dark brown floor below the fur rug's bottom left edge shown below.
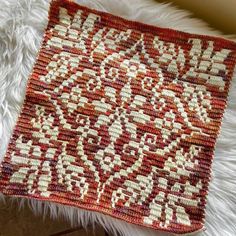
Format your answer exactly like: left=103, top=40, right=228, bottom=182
left=0, top=199, right=108, bottom=236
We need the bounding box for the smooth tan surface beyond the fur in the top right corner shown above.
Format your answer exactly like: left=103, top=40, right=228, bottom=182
left=157, top=0, right=236, bottom=35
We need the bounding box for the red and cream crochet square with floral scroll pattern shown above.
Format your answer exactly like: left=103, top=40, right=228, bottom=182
left=0, top=0, right=236, bottom=233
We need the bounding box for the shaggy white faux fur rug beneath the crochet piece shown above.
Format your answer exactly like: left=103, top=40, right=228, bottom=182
left=0, top=0, right=236, bottom=236
